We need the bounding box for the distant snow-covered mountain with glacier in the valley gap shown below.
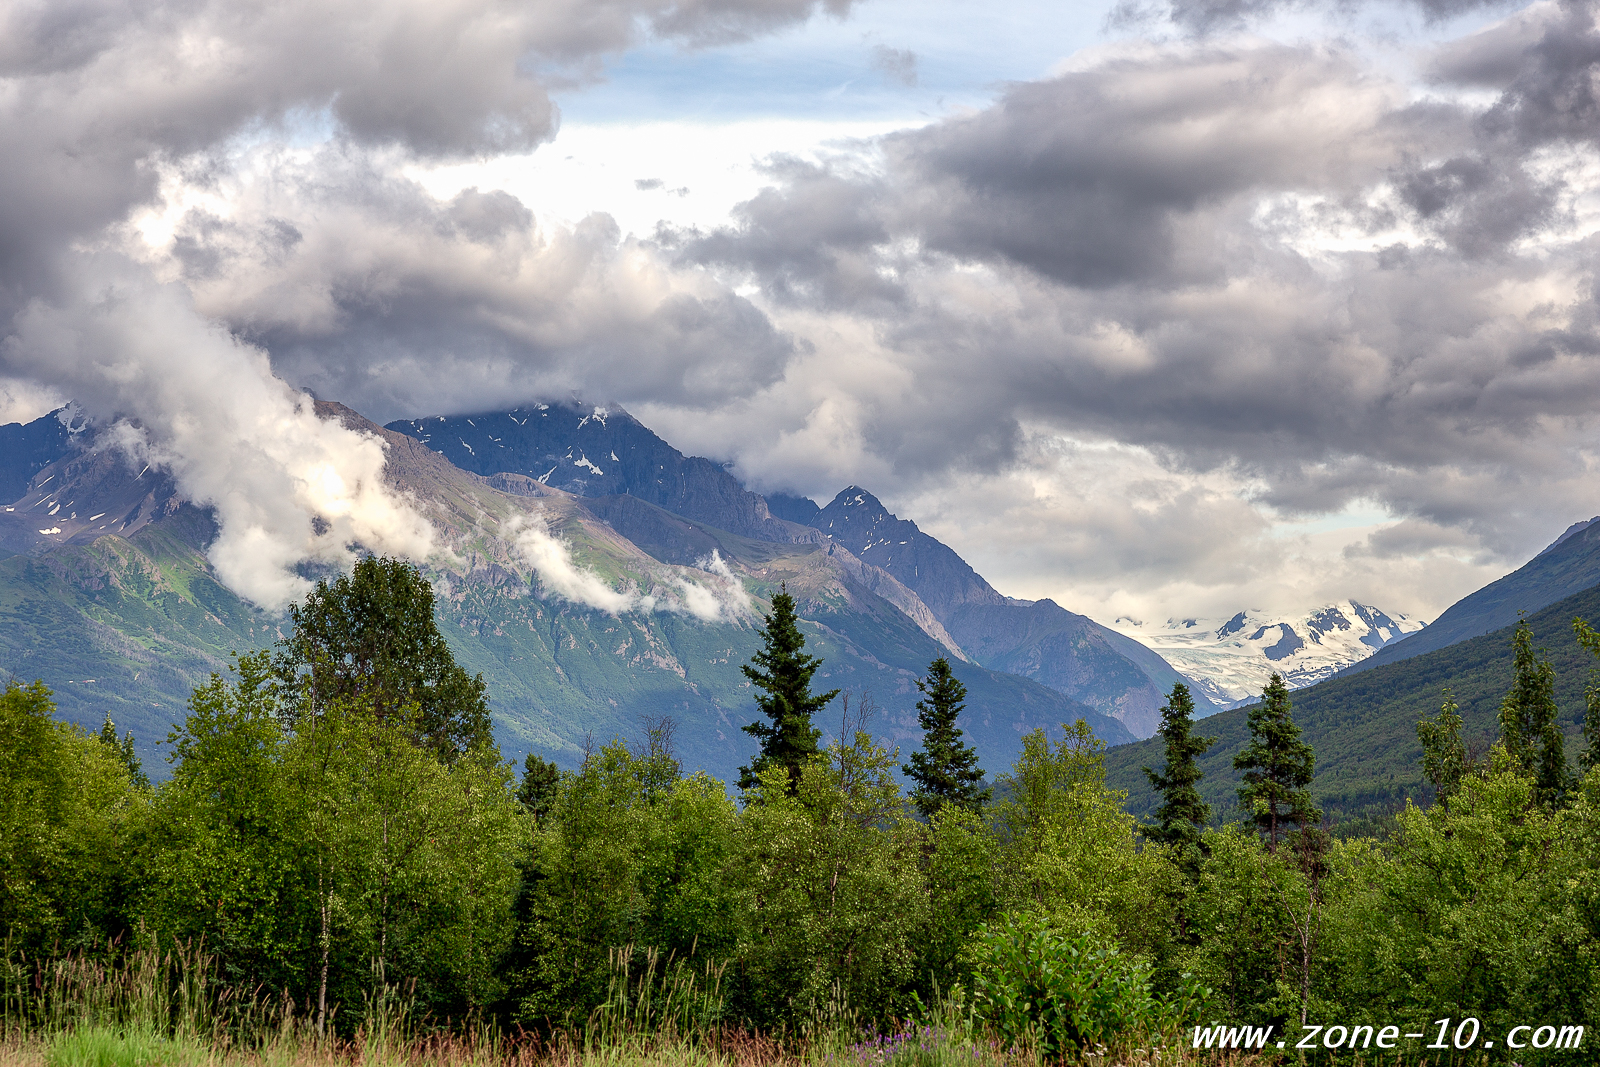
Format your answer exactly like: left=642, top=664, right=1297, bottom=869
left=1112, top=600, right=1426, bottom=707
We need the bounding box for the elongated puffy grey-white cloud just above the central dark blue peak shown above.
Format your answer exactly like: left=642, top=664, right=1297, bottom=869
left=134, top=147, right=795, bottom=421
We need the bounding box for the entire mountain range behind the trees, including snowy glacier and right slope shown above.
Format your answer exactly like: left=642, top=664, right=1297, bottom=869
left=12, top=396, right=1600, bottom=813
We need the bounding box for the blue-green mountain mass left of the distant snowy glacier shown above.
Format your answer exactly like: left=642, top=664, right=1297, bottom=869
left=0, top=403, right=1203, bottom=779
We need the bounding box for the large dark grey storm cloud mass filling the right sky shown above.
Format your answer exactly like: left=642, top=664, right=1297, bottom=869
left=688, top=18, right=1600, bottom=550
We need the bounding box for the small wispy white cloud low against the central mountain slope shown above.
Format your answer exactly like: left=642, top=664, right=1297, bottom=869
left=506, top=515, right=754, bottom=622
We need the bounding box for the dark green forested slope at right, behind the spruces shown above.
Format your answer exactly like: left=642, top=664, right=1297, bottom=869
left=1106, top=589, right=1600, bottom=821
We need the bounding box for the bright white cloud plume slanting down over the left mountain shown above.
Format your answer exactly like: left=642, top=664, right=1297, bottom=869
left=5, top=261, right=434, bottom=609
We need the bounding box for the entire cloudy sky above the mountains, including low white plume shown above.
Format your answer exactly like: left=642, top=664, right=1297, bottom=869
left=0, top=0, right=1600, bottom=625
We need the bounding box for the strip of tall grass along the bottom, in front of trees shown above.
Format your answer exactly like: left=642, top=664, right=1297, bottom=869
left=0, top=945, right=1312, bottom=1067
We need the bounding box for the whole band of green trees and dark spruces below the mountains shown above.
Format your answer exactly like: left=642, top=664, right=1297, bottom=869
left=9, top=560, right=1600, bottom=1064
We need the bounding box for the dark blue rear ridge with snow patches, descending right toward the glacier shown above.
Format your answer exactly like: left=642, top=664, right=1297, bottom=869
left=386, top=405, right=1213, bottom=737
